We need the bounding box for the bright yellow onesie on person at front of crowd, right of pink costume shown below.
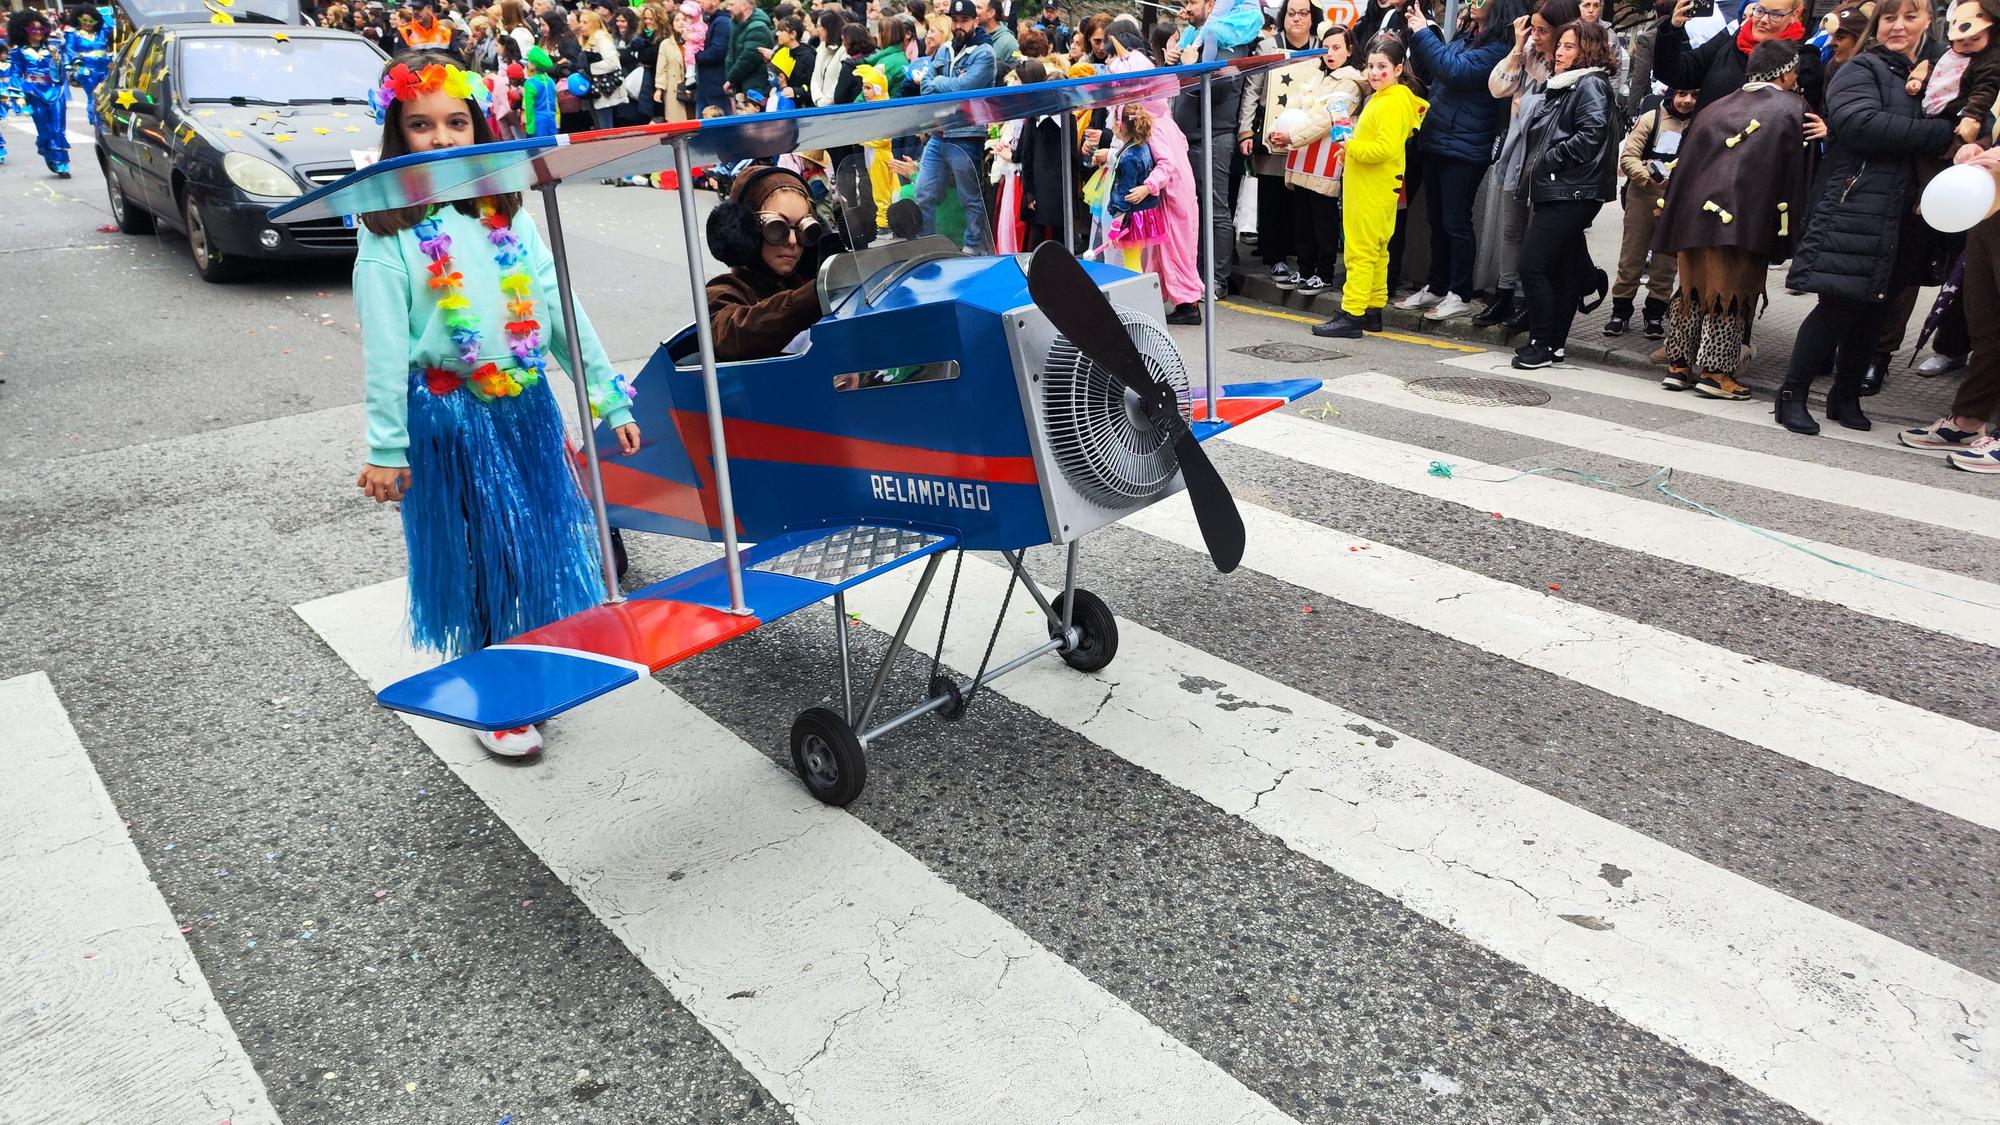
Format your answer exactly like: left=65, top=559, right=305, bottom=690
left=1340, top=82, right=1430, bottom=320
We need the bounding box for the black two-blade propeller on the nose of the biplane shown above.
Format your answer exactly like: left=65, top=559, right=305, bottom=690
left=1028, top=242, right=1244, bottom=575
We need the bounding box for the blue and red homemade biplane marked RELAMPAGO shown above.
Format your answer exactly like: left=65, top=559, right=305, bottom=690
left=272, top=56, right=1320, bottom=805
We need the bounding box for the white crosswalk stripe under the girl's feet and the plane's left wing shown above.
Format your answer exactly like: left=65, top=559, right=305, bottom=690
left=298, top=583, right=1290, bottom=1125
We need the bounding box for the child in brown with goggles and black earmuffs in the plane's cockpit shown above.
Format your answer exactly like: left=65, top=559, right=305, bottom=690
left=708, top=166, right=826, bottom=362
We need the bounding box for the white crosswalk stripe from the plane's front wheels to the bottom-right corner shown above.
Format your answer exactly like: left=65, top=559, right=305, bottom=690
left=848, top=556, right=2000, bottom=1125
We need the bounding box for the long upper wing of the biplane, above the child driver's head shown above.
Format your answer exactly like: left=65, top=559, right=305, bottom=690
left=270, top=50, right=1320, bottom=222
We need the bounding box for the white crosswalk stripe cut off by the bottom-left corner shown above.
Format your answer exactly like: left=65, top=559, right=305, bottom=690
left=0, top=675, right=278, bottom=1125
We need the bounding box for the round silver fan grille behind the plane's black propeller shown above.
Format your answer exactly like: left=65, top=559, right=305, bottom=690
left=1042, top=304, right=1188, bottom=508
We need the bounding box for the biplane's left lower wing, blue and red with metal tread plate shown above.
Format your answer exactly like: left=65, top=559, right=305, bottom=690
left=376, top=524, right=958, bottom=731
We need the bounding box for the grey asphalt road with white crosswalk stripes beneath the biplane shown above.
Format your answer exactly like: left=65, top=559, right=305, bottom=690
left=0, top=107, right=2000, bottom=1125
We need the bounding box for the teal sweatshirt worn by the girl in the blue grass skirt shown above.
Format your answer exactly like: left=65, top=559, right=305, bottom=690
left=354, top=206, right=632, bottom=468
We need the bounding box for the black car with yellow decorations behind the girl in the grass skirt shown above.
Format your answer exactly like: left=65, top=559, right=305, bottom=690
left=96, top=12, right=386, bottom=282
